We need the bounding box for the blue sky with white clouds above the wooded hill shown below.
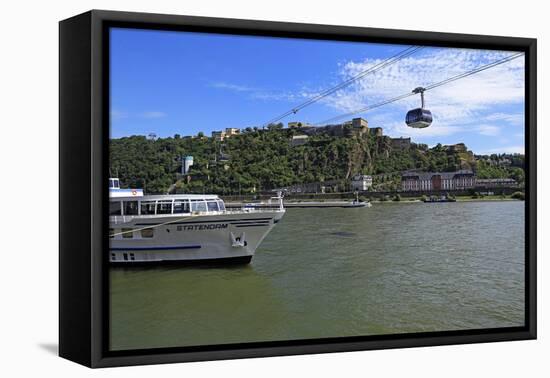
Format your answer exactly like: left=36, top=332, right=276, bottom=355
left=111, top=29, right=524, bottom=153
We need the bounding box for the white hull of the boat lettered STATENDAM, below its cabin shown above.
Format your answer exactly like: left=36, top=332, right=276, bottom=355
left=109, top=210, right=284, bottom=265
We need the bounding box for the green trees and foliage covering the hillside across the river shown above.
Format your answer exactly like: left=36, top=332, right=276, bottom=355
left=110, top=129, right=523, bottom=195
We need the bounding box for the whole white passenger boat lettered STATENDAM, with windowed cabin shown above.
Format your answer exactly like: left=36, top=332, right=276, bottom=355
left=109, top=178, right=285, bottom=264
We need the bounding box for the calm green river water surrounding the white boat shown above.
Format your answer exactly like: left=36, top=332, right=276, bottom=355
left=110, top=201, right=525, bottom=350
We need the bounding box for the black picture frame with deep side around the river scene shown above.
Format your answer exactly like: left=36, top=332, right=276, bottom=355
left=59, top=10, right=537, bottom=367
